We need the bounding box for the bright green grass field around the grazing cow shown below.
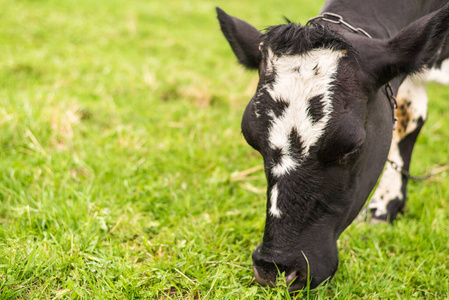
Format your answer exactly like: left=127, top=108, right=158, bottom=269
left=0, top=0, right=449, bottom=299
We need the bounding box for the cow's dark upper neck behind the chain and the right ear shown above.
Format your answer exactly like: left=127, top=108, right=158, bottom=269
left=321, top=0, right=447, bottom=38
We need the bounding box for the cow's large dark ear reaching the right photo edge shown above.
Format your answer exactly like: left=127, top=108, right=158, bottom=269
left=363, top=3, right=449, bottom=86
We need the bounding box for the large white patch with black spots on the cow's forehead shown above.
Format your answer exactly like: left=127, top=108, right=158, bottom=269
left=267, top=49, right=344, bottom=177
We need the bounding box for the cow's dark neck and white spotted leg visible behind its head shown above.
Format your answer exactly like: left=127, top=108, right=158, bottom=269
left=321, top=0, right=449, bottom=222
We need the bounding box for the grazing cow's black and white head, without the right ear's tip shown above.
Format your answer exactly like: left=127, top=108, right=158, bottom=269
left=218, top=4, right=449, bottom=290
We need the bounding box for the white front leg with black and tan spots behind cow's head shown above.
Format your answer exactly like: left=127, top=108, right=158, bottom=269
left=366, top=77, right=428, bottom=222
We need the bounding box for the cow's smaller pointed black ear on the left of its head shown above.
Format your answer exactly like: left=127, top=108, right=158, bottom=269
left=217, top=7, right=262, bottom=69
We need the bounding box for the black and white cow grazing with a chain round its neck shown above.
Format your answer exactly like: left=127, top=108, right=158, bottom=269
left=217, top=0, right=449, bottom=290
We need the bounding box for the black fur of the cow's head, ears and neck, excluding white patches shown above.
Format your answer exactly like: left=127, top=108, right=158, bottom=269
left=217, top=0, right=449, bottom=289
